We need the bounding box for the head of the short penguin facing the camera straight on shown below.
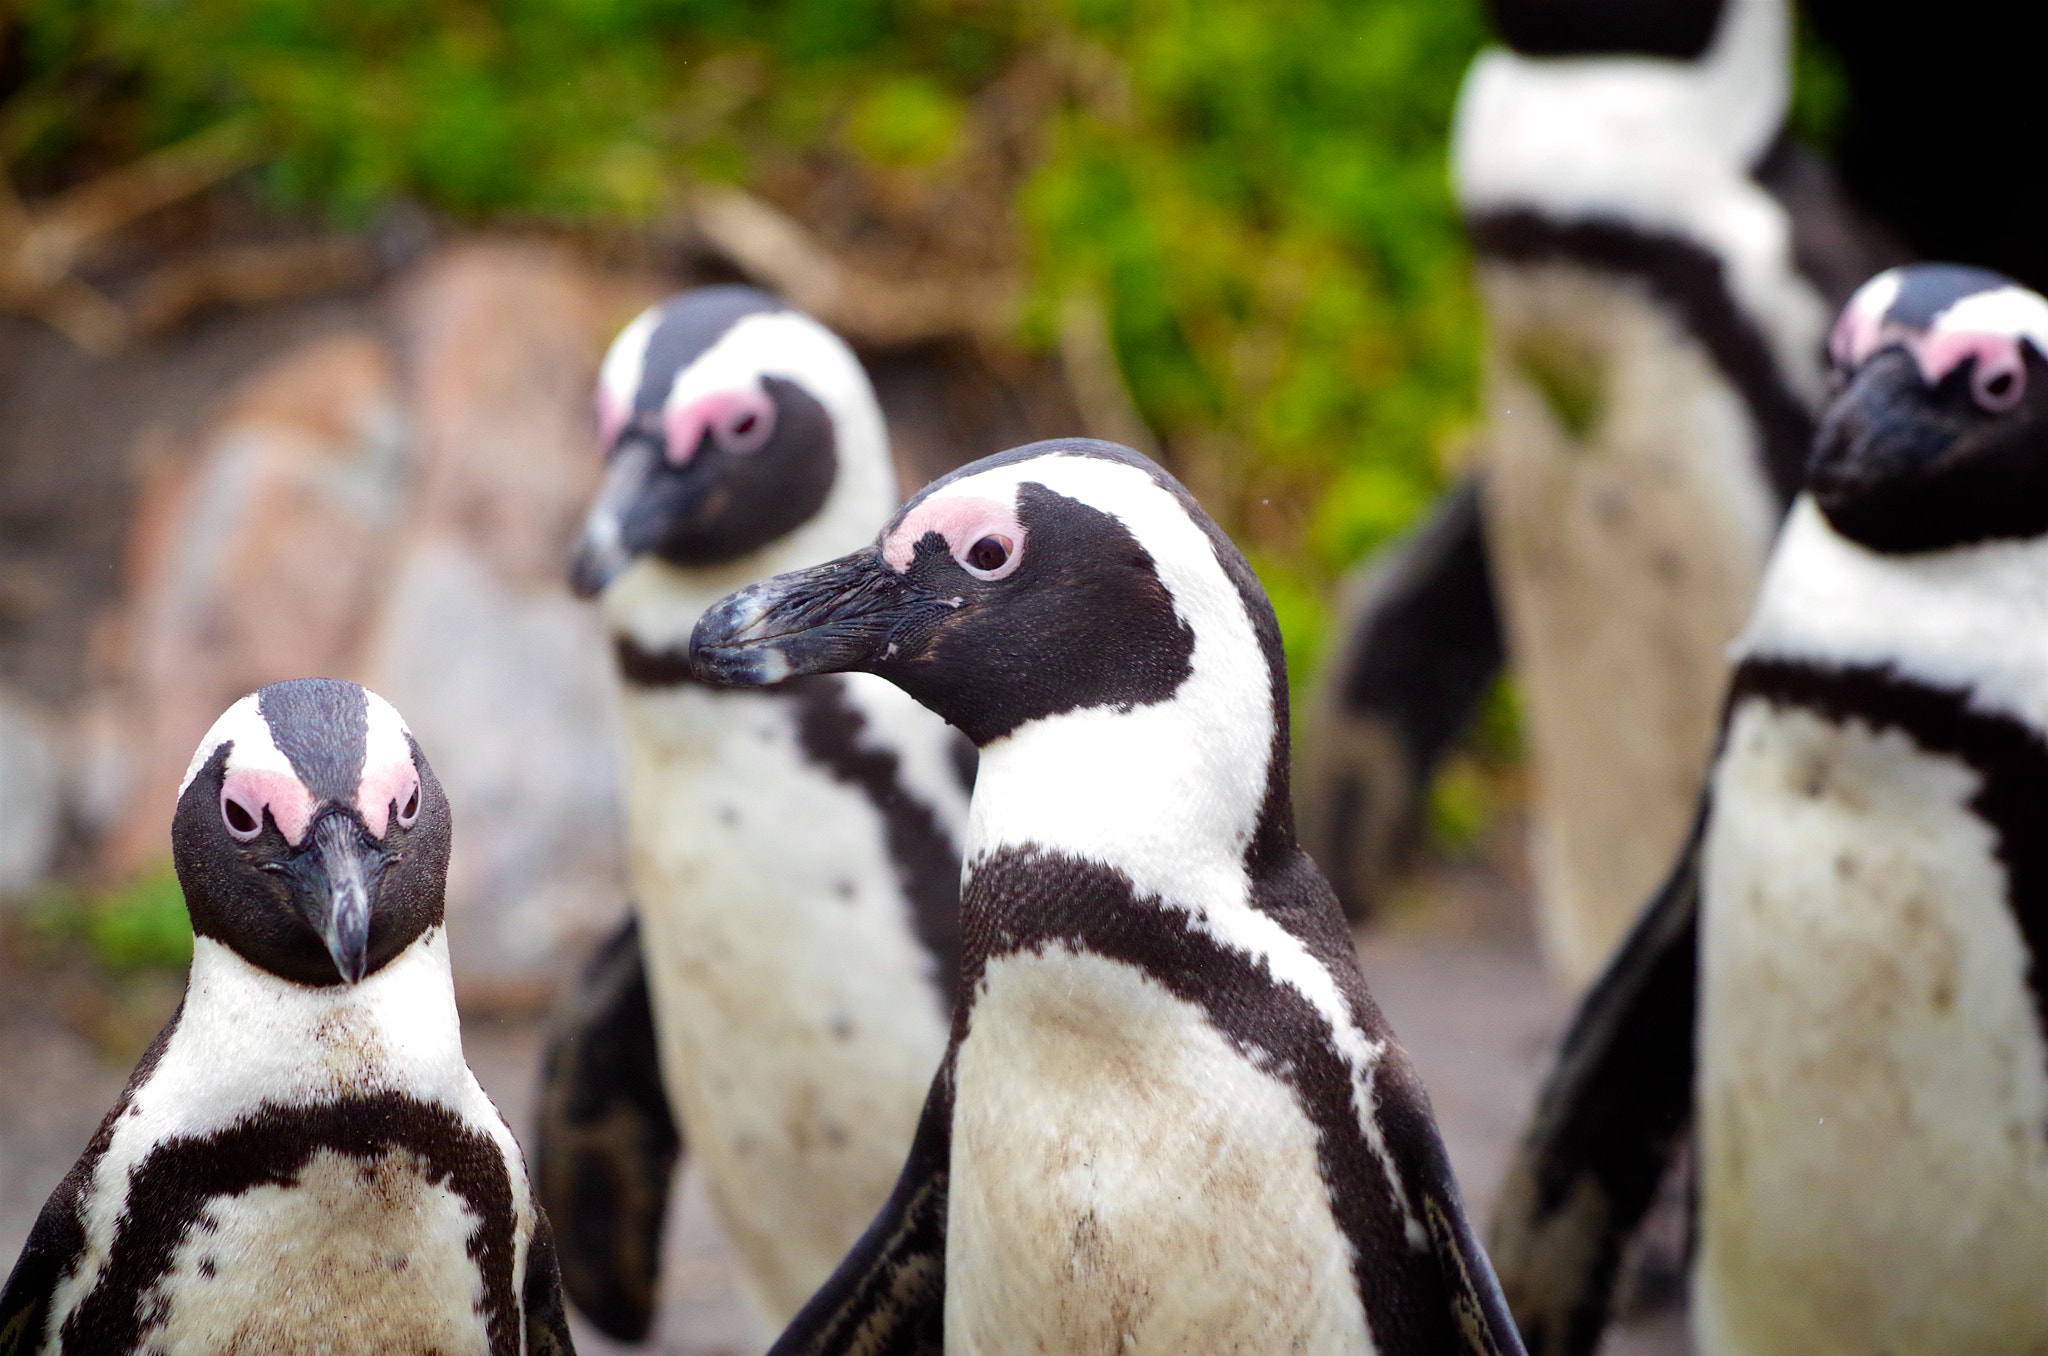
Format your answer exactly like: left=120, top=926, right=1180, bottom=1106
left=170, top=678, right=449, bottom=985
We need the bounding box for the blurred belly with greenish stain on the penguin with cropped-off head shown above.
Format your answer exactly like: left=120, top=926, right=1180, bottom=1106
left=1481, top=264, right=1785, bottom=983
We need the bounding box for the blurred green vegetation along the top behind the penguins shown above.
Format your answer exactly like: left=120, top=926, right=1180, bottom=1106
left=0, top=0, right=1485, bottom=684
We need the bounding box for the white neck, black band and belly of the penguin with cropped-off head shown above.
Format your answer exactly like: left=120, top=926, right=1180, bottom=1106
left=1454, top=0, right=1829, bottom=983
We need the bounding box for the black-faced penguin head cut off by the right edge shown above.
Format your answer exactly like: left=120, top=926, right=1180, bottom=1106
left=1806, top=264, right=2048, bottom=553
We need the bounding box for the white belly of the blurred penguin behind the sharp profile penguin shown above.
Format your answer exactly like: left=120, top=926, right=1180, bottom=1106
left=627, top=676, right=965, bottom=1327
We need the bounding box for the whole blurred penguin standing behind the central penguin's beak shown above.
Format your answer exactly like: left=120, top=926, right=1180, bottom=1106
left=537, top=287, right=973, bottom=1340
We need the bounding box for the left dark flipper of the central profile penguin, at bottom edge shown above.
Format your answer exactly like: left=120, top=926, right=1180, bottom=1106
left=768, top=1051, right=952, bottom=1356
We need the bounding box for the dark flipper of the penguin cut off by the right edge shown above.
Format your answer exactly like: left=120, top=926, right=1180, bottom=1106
left=1491, top=797, right=1708, bottom=1356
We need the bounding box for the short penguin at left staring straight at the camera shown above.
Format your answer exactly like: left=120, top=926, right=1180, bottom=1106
left=0, top=678, right=571, bottom=1356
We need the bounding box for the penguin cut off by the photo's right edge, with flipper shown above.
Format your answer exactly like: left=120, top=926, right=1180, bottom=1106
left=1493, top=264, right=2048, bottom=1356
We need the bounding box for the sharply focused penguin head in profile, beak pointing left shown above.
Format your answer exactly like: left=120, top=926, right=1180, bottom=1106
left=690, top=438, right=1286, bottom=746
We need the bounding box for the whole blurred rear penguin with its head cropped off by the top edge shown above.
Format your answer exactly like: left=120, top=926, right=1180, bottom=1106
left=1305, top=0, right=1901, bottom=985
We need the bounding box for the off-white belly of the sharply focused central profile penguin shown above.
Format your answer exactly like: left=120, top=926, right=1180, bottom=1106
left=946, top=946, right=1372, bottom=1356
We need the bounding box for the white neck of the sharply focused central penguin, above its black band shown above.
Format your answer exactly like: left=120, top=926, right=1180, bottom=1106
left=967, top=647, right=1284, bottom=925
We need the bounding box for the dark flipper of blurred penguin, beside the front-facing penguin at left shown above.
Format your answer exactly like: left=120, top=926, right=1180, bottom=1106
left=532, top=916, right=682, bottom=1342
